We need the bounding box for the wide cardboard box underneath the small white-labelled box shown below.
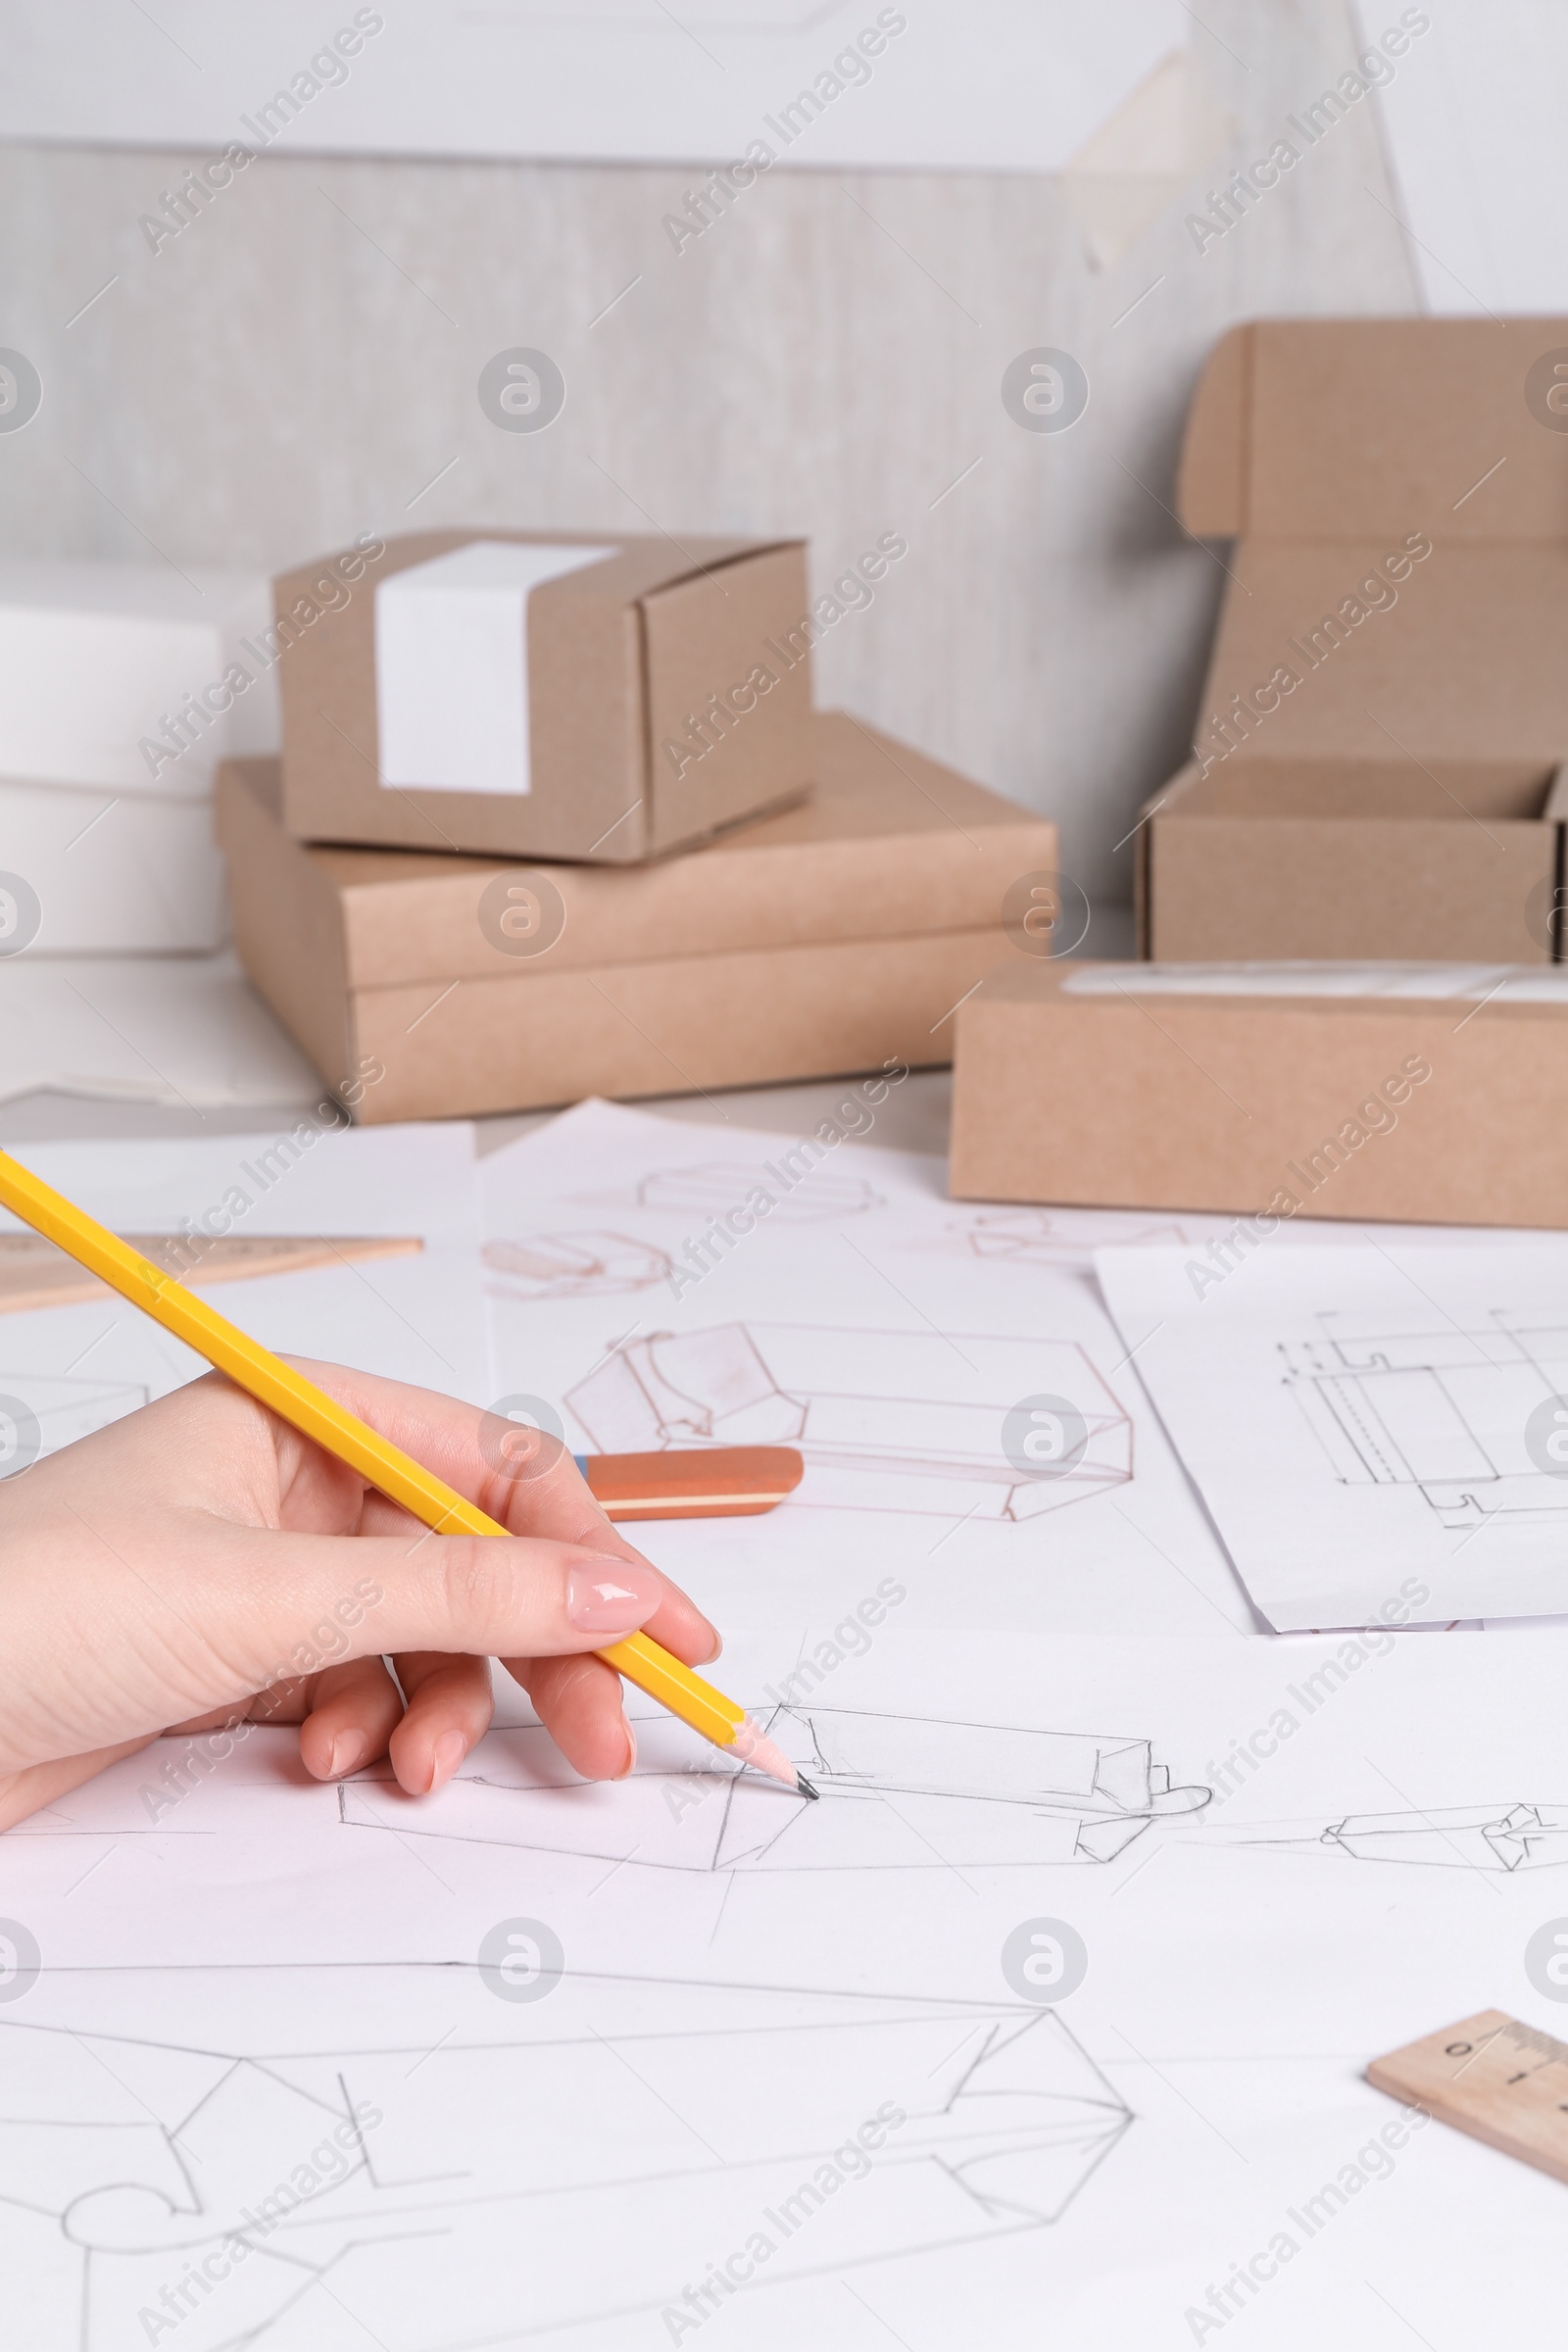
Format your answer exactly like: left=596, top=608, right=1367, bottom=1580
left=219, top=715, right=1055, bottom=1122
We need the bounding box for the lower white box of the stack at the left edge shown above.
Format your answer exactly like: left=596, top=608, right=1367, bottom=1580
left=0, top=778, right=228, bottom=955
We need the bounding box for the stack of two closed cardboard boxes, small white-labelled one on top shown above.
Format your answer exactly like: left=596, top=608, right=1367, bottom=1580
left=219, top=531, right=1055, bottom=1119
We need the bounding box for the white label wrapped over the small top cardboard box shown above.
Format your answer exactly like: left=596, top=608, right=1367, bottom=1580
left=376, top=539, right=620, bottom=793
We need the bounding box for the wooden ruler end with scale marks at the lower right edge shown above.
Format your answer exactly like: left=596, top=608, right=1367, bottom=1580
left=1366, top=2009, right=1568, bottom=2180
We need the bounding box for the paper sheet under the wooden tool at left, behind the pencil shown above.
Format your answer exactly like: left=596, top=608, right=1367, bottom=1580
left=0, top=1122, right=491, bottom=1453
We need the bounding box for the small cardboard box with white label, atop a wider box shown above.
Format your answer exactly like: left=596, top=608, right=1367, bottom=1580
left=275, top=531, right=820, bottom=865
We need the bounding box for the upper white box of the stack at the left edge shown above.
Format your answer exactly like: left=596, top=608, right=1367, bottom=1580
left=0, top=558, right=277, bottom=800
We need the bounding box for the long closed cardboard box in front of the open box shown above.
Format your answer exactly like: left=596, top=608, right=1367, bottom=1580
left=950, top=959, right=1568, bottom=1225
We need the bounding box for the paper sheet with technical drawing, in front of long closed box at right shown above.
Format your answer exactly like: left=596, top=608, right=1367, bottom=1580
left=1096, top=1235, right=1568, bottom=1630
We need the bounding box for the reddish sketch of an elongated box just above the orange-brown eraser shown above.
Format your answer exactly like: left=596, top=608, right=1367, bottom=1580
left=566, top=1322, right=1133, bottom=1519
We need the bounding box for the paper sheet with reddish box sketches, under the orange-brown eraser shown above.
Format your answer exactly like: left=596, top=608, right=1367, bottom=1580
left=479, top=1084, right=1255, bottom=1633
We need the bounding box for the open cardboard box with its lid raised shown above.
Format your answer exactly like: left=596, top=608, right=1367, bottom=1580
left=1138, top=318, right=1568, bottom=962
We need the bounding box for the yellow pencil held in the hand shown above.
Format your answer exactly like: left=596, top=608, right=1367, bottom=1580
left=0, top=1152, right=815, bottom=1797
